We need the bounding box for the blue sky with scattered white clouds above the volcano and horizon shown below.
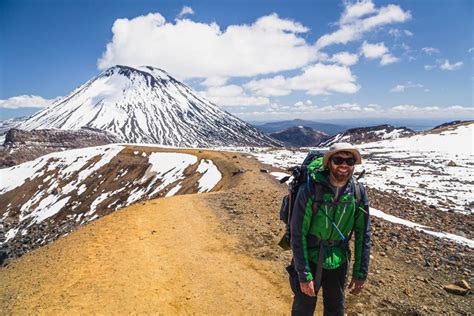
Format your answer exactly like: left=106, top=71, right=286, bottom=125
left=0, top=0, right=474, bottom=121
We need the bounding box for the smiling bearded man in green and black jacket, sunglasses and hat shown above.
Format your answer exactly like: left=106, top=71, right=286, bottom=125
left=287, top=143, right=370, bottom=315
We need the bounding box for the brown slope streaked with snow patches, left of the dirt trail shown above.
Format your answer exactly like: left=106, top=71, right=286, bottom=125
left=0, top=145, right=220, bottom=258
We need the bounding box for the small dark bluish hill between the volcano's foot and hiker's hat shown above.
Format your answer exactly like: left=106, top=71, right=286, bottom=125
left=270, top=126, right=329, bottom=147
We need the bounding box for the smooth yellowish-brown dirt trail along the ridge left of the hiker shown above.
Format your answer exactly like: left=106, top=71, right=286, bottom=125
left=0, top=152, right=291, bottom=315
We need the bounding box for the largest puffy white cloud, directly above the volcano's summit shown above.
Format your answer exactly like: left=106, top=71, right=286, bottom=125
left=97, top=13, right=316, bottom=79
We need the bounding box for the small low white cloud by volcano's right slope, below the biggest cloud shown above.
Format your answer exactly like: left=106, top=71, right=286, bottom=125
left=200, top=85, right=270, bottom=106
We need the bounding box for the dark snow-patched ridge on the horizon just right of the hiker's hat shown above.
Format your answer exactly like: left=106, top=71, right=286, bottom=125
left=319, top=124, right=415, bottom=147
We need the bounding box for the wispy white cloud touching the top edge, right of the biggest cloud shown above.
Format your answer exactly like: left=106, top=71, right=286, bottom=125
left=315, top=0, right=411, bottom=49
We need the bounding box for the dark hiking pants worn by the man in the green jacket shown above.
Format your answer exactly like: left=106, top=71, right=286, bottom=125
left=287, top=262, right=347, bottom=316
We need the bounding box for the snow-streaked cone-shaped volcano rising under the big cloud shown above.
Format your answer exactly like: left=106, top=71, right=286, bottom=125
left=17, top=66, right=279, bottom=147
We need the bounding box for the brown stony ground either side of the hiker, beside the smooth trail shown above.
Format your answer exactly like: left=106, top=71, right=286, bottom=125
left=210, top=157, right=474, bottom=315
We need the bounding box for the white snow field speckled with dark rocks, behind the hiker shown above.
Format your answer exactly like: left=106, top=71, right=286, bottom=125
left=264, top=124, right=474, bottom=248
